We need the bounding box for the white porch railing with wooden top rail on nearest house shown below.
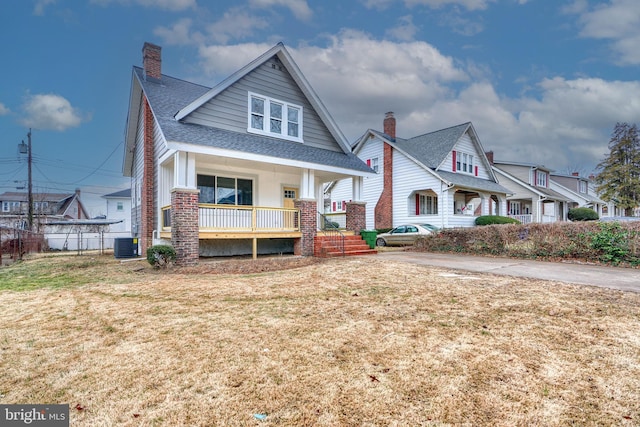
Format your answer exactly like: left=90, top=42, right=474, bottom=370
left=162, top=204, right=300, bottom=232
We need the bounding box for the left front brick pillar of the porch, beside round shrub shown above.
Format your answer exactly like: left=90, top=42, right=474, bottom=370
left=171, top=189, right=200, bottom=265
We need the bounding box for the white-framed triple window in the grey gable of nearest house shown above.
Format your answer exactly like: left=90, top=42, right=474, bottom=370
left=247, top=92, right=302, bottom=142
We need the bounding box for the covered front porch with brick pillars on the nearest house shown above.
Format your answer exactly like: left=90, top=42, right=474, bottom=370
left=154, top=152, right=364, bottom=260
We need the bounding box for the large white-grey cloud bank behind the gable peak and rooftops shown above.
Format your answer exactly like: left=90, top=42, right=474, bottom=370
left=200, top=30, right=640, bottom=172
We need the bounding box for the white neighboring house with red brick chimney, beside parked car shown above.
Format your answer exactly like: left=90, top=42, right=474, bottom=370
left=324, top=113, right=509, bottom=229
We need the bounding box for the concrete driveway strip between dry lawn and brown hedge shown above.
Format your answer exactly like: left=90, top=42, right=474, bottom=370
left=375, top=250, right=640, bottom=292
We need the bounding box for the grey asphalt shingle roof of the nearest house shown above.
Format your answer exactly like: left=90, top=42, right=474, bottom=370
left=134, top=67, right=371, bottom=172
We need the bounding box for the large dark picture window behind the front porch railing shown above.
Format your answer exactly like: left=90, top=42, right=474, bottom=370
left=198, top=175, right=253, bottom=206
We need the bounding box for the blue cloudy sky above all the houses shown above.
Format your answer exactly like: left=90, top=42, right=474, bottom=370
left=0, top=0, right=640, bottom=215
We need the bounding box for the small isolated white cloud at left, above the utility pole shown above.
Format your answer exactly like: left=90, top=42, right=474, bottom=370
left=21, top=94, right=88, bottom=131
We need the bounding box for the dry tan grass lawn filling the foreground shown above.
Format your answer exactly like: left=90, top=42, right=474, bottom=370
left=0, top=256, right=640, bottom=426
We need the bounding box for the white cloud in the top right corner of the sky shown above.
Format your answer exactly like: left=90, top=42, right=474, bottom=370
left=564, top=0, right=640, bottom=65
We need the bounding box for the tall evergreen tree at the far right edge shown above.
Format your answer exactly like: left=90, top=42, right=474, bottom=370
left=596, top=123, right=640, bottom=216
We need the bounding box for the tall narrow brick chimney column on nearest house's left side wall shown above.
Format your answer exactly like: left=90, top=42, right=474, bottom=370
left=140, top=98, right=156, bottom=256
